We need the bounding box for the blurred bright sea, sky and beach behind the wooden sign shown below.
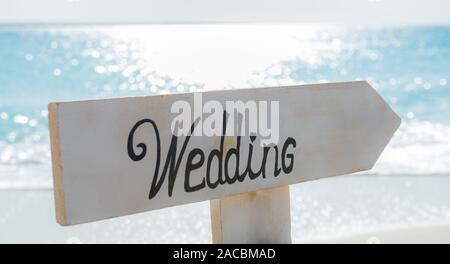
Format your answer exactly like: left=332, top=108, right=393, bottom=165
left=0, top=0, right=450, bottom=243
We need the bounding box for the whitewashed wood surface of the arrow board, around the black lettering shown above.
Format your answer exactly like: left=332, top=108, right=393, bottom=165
left=49, top=82, right=400, bottom=225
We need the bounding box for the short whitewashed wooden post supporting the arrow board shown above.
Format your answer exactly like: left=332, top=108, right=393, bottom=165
left=210, top=186, right=292, bottom=244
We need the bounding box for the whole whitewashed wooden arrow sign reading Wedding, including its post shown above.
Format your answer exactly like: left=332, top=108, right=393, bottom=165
left=49, top=81, right=400, bottom=243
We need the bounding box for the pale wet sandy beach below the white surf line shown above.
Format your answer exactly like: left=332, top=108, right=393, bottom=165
left=0, top=175, right=450, bottom=243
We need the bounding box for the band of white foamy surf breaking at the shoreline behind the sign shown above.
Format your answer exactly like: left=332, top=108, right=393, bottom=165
left=0, top=121, right=450, bottom=189
